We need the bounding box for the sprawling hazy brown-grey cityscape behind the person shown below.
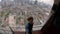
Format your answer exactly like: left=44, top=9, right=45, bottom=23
left=0, top=0, right=52, bottom=31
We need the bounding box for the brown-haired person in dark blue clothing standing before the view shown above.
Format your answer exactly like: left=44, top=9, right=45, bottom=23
left=25, top=17, right=33, bottom=34
